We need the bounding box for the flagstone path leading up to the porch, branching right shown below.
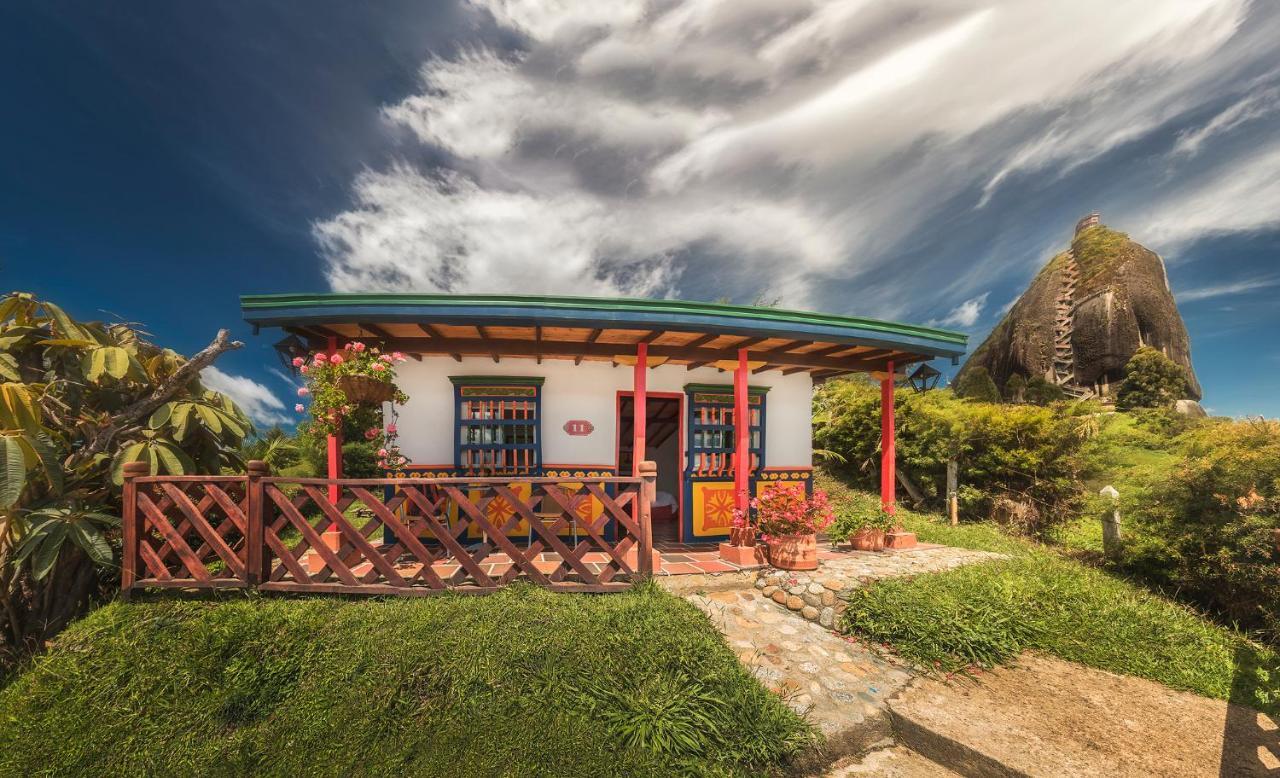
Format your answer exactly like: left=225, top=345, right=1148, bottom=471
left=658, top=546, right=998, bottom=759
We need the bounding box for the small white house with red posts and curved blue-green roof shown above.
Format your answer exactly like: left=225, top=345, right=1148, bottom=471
left=241, top=294, right=965, bottom=543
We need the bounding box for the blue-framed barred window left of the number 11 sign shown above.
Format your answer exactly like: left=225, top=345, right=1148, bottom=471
left=449, top=376, right=543, bottom=476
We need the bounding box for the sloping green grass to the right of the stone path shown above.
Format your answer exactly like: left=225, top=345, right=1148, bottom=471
left=822, top=470, right=1280, bottom=713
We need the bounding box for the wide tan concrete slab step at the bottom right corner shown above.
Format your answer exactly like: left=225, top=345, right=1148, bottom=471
left=890, top=654, right=1280, bottom=778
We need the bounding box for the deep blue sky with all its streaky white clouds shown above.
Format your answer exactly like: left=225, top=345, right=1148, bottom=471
left=0, top=0, right=1280, bottom=422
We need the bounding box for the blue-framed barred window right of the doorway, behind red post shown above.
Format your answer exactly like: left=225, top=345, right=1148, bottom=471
left=686, top=386, right=765, bottom=477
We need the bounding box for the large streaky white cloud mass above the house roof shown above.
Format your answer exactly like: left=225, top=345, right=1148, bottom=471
left=315, top=0, right=1276, bottom=309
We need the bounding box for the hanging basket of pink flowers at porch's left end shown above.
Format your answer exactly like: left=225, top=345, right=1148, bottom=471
left=293, top=340, right=408, bottom=470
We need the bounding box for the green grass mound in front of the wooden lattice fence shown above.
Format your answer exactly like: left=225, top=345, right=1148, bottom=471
left=0, top=586, right=812, bottom=775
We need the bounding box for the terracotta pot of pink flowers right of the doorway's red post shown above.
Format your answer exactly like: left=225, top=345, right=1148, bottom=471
left=751, top=484, right=833, bottom=569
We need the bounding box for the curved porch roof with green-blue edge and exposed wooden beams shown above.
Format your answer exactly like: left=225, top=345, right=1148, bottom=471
left=241, top=294, right=965, bottom=377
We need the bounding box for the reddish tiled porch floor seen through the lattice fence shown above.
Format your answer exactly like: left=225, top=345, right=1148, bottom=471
left=302, top=541, right=942, bottom=577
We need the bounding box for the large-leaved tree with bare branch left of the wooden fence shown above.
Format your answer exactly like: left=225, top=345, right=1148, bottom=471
left=0, top=292, right=251, bottom=654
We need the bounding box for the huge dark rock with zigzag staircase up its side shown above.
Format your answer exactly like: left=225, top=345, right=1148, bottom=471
left=956, top=214, right=1201, bottom=399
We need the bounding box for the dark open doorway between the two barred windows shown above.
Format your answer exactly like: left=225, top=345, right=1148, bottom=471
left=618, top=392, right=684, bottom=541
